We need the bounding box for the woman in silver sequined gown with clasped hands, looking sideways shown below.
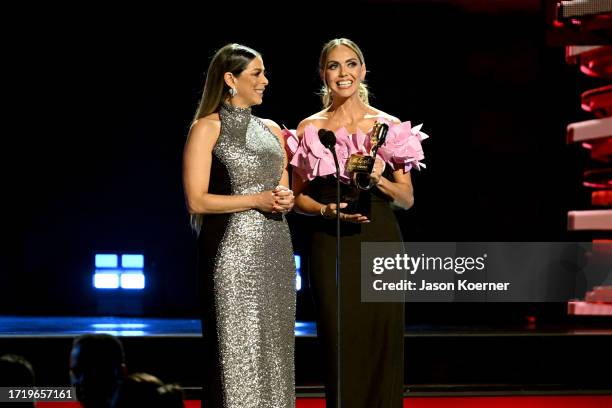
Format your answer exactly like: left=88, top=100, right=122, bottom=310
left=183, top=44, right=295, bottom=408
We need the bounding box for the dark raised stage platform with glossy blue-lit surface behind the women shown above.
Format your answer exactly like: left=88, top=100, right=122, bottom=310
left=0, top=316, right=612, bottom=396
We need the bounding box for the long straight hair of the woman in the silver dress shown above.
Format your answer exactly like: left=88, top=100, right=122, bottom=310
left=189, top=43, right=261, bottom=235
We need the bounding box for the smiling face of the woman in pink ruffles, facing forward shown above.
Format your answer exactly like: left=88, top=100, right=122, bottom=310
left=321, top=45, right=366, bottom=98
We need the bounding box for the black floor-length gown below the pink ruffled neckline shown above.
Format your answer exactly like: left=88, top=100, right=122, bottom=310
left=308, top=173, right=404, bottom=408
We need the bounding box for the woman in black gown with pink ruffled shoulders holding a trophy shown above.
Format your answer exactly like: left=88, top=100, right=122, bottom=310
left=286, top=38, right=422, bottom=408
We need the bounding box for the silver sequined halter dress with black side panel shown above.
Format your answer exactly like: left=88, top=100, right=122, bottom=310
left=198, top=105, right=295, bottom=408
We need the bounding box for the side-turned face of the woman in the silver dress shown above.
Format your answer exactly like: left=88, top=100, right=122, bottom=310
left=225, top=56, right=268, bottom=108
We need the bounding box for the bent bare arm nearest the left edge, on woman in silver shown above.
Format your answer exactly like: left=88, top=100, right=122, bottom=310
left=183, top=118, right=274, bottom=214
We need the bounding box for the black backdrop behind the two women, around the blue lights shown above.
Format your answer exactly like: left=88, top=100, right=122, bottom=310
left=0, top=0, right=603, bottom=322
